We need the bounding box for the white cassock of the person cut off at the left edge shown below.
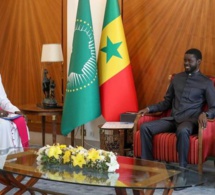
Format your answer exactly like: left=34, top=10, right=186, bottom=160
left=0, top=75, right=29, bottom=149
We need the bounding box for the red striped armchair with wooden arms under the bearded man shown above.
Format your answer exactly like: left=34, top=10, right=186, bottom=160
left=133, top=77, right=215, bottom=173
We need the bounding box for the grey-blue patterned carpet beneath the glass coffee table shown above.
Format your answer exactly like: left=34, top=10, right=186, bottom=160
left=0, top=161, right=215, bottom=195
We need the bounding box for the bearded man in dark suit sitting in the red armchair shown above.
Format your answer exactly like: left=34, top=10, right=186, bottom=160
left=139, top=49, right=215, bottom=167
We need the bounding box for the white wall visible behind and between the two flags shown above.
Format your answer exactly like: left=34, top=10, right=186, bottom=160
left=67, top=0, right=106, bottom=141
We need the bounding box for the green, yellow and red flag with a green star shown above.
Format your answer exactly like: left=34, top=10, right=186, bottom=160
left=98, top=0, right=138, bottom=121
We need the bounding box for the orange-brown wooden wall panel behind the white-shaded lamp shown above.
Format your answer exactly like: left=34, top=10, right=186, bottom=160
left=0, top=0, right=66, bottom=106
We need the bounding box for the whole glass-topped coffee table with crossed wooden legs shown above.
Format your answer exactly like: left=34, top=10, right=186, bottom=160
left=0, top=148, right=203, bottom=195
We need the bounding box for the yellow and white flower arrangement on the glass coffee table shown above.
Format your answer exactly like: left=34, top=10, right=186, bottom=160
left=37, top=144, right=119, bottom=172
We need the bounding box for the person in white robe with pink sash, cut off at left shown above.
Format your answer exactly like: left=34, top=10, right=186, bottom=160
left=0, top=75, right=29, bottom=149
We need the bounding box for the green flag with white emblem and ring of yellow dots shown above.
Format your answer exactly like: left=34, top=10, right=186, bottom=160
left=61, top=0, right=101, bottom=135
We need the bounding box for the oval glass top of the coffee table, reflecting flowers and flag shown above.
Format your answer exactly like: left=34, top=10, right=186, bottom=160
left=0, top=148, right=203, bottom=189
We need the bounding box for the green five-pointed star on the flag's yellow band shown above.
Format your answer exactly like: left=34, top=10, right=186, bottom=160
left=101, top=37, right=122, bottom=62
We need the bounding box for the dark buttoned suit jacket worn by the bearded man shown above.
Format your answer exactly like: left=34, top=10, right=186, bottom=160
left=149, top=72, right=215, bottom=122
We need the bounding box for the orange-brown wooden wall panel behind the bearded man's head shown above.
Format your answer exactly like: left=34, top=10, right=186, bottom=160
left=123, top=0, right=215, bottom=108
